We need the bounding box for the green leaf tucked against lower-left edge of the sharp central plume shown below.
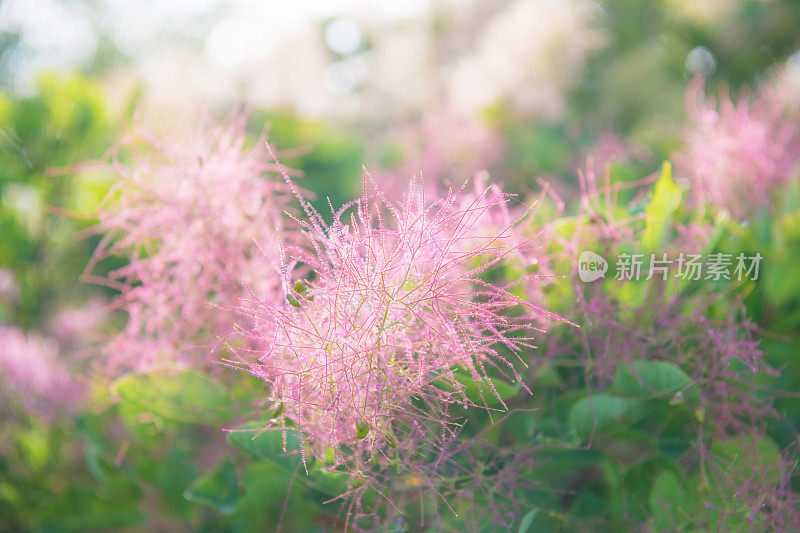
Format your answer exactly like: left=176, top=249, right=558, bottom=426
left=228, top=422, right=301, bottom=472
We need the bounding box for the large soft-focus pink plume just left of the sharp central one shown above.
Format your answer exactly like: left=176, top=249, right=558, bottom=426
left=86, top=115, right=289, bottom=369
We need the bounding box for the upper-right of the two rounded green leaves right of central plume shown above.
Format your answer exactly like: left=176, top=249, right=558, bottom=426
left=612, top=360, right=690, bottom=397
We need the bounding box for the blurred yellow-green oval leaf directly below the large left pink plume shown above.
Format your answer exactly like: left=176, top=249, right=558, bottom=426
left=111, top=371, right=236, bottom=424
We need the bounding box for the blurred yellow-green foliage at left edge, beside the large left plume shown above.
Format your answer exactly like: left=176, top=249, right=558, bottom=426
left=0, top=72, right=116, bottom=328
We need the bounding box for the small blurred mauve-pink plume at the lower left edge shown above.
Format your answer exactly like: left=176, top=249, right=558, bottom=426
left=0, top=325, right=83, bottom=418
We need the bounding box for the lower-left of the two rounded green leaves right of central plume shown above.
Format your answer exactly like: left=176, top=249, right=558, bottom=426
left=569, top=394, right=641, bottom=440
